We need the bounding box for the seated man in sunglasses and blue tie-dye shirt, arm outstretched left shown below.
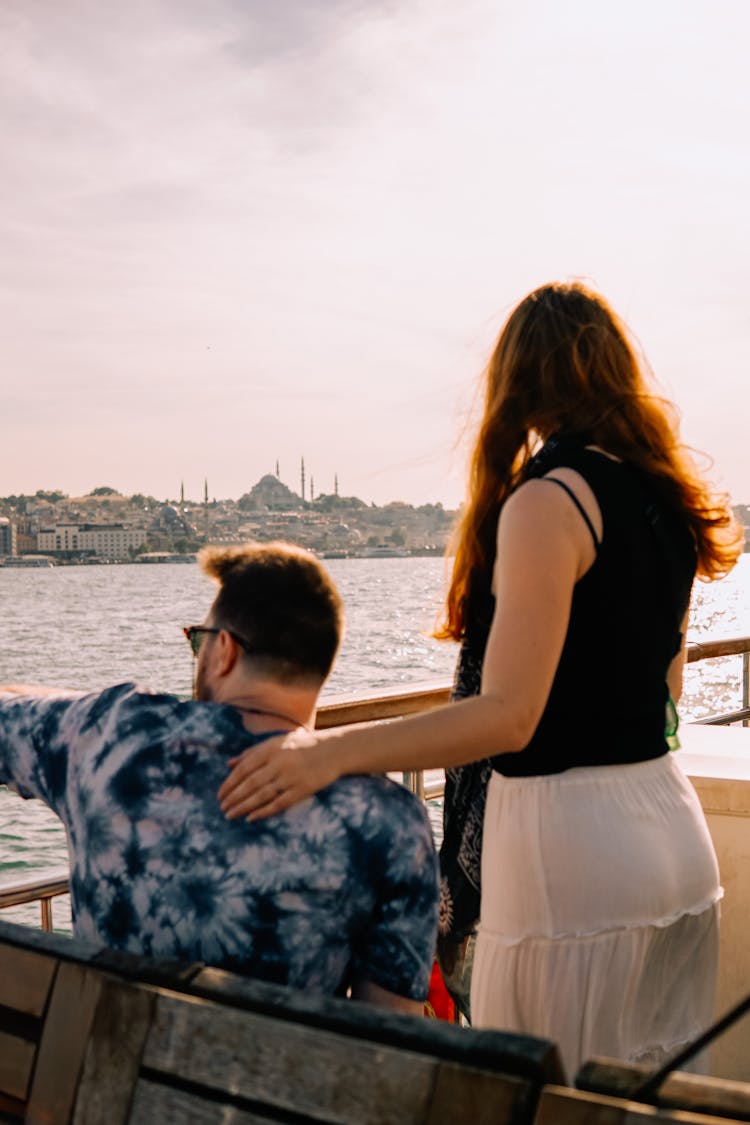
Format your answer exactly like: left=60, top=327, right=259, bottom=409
left=0, top=543, right=437, bottom=1013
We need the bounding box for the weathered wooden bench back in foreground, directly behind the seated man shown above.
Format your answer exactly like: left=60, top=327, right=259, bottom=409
left=0, top=923, right=562, bottom=1125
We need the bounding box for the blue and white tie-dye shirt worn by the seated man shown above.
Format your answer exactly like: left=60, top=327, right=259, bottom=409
left=0, top=684, right=437, bottom=999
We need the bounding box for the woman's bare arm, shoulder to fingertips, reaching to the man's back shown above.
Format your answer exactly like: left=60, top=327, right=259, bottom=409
left=219, top=480, right=593, bottom=819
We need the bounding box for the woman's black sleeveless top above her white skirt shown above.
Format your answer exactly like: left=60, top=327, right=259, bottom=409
left=455, top=438, right=696, bottom=777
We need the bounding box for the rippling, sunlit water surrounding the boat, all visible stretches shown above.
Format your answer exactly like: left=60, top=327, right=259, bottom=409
left=0, top=555, right=750, bottom=929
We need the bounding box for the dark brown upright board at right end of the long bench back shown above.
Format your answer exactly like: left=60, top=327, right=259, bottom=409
left=425, top=1062, right=539, bottom=1125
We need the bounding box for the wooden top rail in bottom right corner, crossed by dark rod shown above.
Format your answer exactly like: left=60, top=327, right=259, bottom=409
left=576, top=1059, right=750, bottom=1122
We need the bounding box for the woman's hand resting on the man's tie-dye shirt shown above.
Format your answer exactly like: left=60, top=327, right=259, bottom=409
left=218, top=730, right=340, bottom=820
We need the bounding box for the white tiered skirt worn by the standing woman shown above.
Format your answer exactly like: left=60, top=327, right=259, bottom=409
left=471, top=754, right=722, bottom=1078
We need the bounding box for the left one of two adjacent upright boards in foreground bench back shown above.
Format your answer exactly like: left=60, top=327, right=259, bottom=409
left=28, top=963, right=102, bottom=1125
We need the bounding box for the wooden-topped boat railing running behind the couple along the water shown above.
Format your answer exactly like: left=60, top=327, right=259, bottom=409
left=0, top=637, right=750, bottom=930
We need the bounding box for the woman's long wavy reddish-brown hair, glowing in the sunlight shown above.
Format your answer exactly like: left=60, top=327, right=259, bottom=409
left=436, top=282, right=741, bottom=640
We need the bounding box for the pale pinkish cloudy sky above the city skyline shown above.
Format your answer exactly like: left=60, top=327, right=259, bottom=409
left=0, top=0, right=750, bottom=507
